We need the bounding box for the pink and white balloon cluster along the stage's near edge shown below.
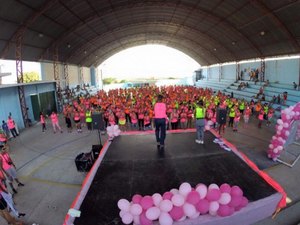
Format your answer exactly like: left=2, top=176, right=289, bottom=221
left=118, top=183, right=248, bottom=225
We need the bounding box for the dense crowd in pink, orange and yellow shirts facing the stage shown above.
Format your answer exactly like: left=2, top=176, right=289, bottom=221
left=52, top=86, right=274, bottom=136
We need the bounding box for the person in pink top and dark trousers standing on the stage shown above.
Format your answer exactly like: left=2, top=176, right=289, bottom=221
left=154, top=95, right=167, bottom=150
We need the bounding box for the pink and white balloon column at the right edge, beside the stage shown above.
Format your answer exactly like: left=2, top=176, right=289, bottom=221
left=268, top=103, right=300, bottom=161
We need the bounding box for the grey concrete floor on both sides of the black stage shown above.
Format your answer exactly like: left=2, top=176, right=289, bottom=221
left=0, top=116, right=300, bottom=225
